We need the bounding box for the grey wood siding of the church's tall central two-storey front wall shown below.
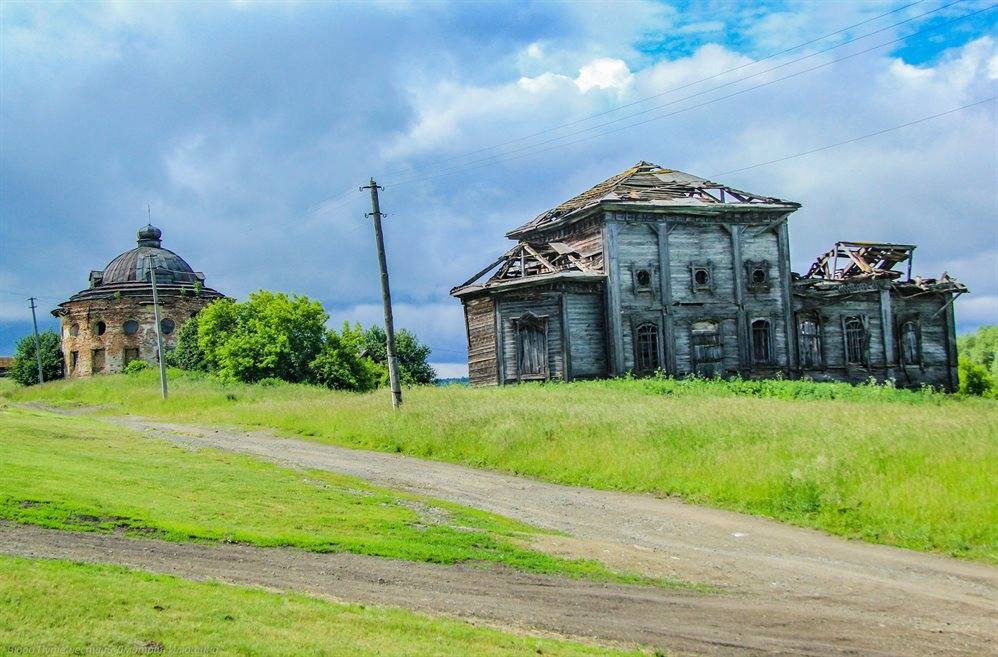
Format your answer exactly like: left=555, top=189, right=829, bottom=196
left=607, top=215, right=792, bottom=376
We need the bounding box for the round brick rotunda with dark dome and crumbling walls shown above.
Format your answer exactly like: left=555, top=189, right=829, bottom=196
left=52, top=225, right=223, bottom=377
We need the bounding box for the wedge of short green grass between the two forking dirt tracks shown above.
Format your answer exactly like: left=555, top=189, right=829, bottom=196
left=0, top=408, right=682, bottom=587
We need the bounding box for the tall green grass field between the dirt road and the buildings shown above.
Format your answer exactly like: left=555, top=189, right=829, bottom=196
left=3, top=372, right=998, bottom=562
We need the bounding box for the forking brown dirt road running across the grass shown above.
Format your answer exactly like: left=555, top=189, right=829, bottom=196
left=0, top=418, right=998, bottom=657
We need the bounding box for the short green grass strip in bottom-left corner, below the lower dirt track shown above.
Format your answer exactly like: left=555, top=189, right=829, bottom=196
left=0, top=556, right=643, bottom=657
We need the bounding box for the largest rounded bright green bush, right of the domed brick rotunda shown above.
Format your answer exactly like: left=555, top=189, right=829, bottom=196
left=198, top=290, right=329, bottom=383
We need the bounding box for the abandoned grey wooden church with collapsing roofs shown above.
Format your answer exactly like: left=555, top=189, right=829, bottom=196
left=451, top=162, right=967, bottom=390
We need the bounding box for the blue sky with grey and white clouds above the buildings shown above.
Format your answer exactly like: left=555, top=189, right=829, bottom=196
left=0, top=0, right=998, bottom=376
